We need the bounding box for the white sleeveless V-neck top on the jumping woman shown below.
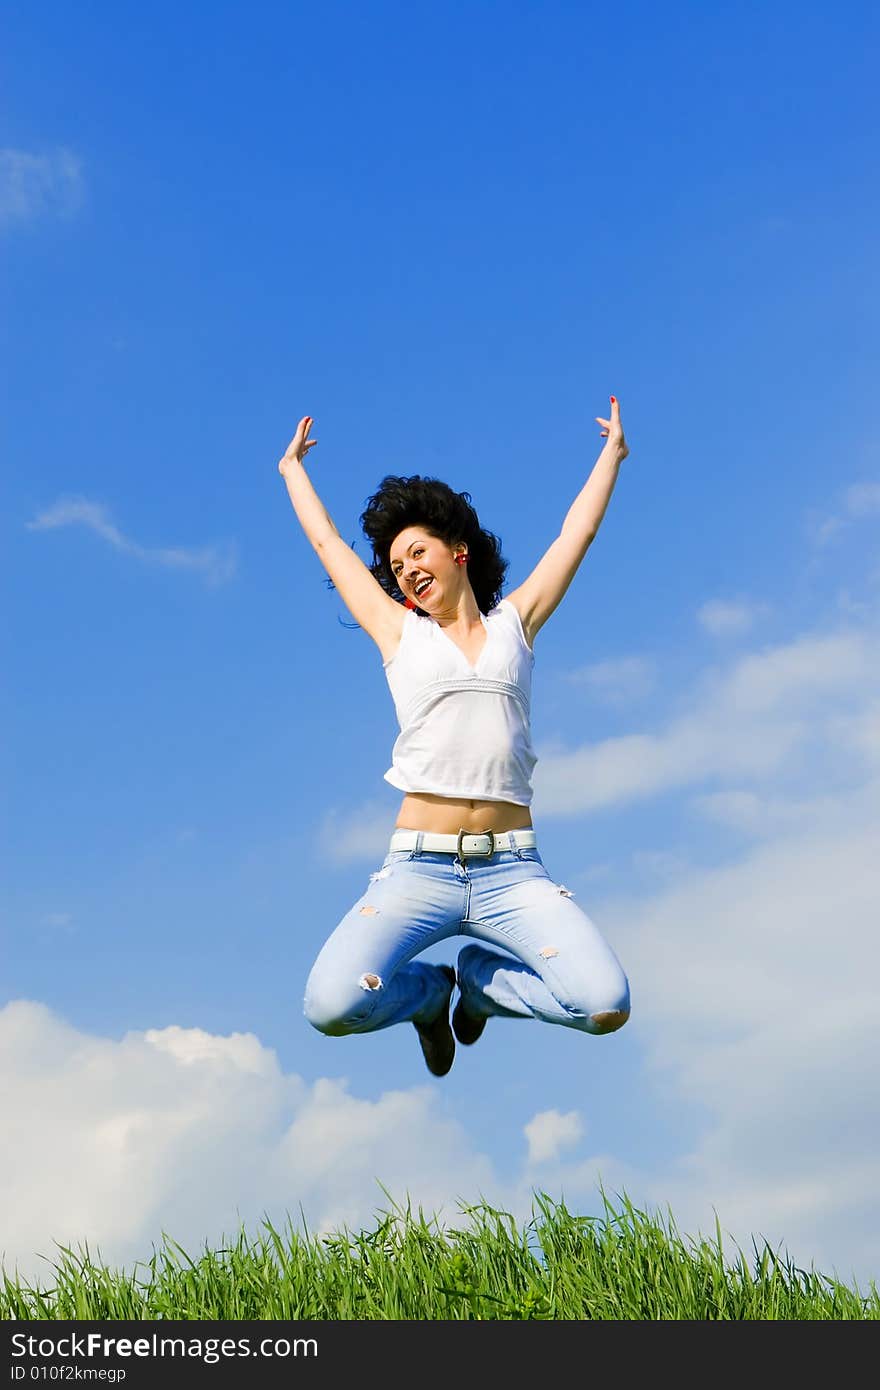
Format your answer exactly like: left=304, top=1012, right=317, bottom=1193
left=382, top=599, right=538, bottom=806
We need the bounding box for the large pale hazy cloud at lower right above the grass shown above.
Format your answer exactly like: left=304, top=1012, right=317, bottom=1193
left=594, top=765, right=880, bottom=1279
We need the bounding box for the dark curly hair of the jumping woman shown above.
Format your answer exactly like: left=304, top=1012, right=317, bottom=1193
left=360, top=474, right=509, bottom=613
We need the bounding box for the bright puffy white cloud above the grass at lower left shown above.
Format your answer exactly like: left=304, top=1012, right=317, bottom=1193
left=0, top=999, right=496, bottom=1279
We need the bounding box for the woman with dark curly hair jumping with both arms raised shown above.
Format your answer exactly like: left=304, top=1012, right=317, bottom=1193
left=278, top=396, right=630, bottom=1076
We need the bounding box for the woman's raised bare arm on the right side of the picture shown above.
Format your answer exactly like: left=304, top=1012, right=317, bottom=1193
left=507, top=396, right=630, bottom=645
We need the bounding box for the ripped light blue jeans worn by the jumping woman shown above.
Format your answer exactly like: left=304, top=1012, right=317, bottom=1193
left=304, top=848, right=630, bottom=1036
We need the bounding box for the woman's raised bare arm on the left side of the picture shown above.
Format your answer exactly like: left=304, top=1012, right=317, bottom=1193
left=278, top=416, right=405, bottom=655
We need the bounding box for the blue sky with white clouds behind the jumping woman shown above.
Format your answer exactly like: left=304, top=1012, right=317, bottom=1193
left=0, top=3, right=880, bottom=1279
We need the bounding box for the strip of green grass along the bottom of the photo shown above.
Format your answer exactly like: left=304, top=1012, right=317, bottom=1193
left=0, top=1193, right=880, bottom=1321
